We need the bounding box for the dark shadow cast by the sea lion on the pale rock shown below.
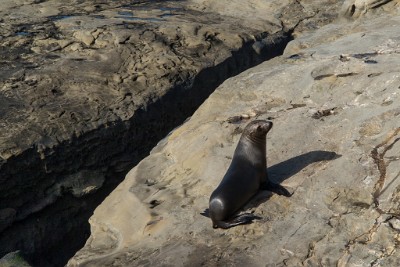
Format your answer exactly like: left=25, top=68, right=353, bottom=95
left=200, top=150, right=342, bottom=218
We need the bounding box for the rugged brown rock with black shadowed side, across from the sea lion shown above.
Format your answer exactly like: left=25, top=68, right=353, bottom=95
left=0, top=0, right=341, bottom=266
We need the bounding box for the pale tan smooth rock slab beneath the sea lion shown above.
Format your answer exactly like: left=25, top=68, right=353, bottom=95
left=68, top=4, right=400, bottom=266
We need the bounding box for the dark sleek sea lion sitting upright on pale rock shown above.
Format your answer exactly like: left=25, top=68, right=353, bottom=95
left=209, top=120, right=289, bottom=229
